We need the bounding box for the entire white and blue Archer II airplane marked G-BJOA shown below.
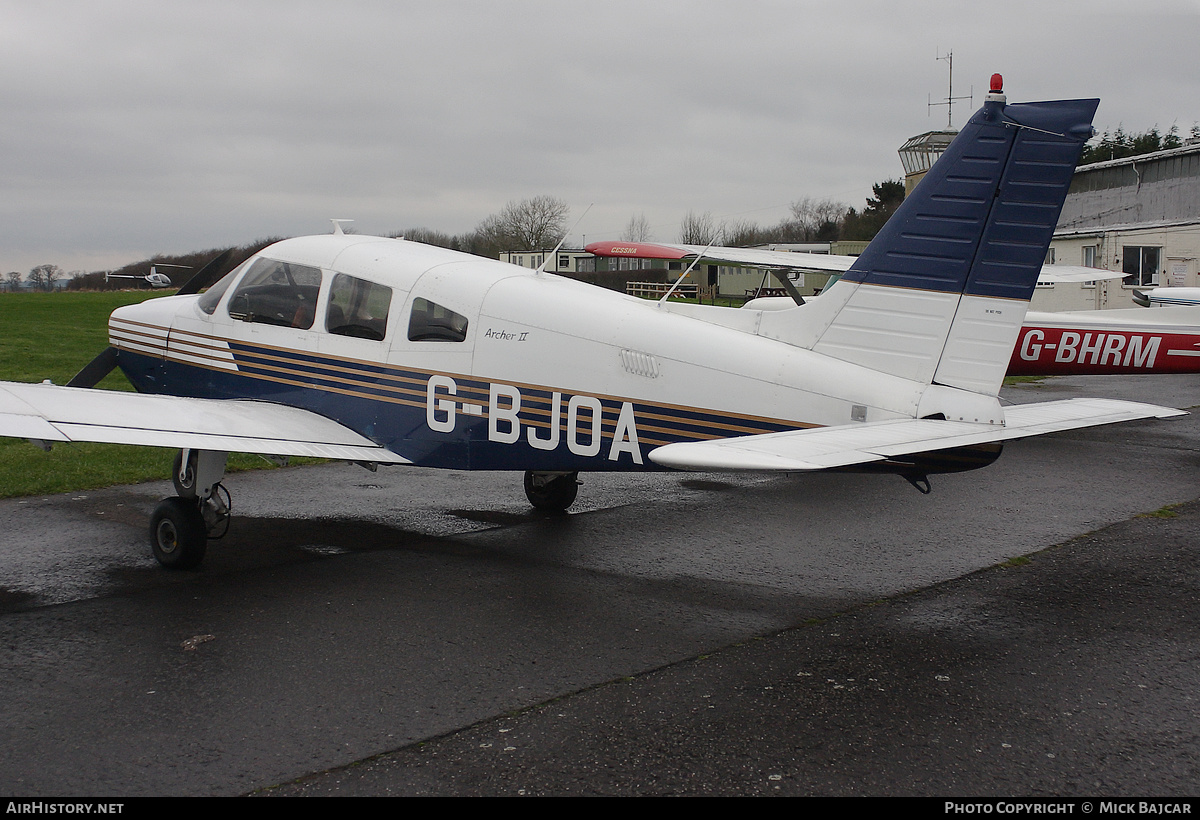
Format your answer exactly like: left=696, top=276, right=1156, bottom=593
left=0, top=81, right=1180, bottom=568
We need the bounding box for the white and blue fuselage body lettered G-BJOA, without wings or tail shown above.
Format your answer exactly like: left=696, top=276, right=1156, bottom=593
left=110, top=235, right=923, bottom=472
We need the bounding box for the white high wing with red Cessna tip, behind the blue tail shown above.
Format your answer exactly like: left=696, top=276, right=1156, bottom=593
left=583, top=243, right=1126, bottom=283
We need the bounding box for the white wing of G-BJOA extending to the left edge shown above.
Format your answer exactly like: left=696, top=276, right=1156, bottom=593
left=0, top=382, right=409, bottom=463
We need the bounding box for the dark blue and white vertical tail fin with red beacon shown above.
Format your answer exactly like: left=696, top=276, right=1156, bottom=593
left=762, top=80, right=1099, bottom=395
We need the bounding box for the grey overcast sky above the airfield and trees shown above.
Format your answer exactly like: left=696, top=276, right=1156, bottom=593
left=0, top=0, right=1200, bottom=273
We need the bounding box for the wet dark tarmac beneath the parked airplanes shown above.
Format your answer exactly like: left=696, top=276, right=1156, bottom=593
left=0, top=377, right=1200, bottom=796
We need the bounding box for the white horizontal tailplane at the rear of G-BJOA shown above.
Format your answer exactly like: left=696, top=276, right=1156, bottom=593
left=649, top=399, right=1186, bottom=472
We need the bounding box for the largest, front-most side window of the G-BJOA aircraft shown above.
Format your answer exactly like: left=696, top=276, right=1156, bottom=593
left=229, top=257, right=320, bottom=330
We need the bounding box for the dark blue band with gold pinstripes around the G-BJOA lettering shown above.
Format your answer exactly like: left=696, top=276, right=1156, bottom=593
left=118, top=342, right=803, bottom=471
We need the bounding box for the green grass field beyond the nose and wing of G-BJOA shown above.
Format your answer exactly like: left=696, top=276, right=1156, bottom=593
left=0, top=291, right=309, bottom=498
